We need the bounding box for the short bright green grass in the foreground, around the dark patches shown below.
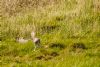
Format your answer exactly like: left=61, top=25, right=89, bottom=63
left=0, top=39, right=100, bottom=67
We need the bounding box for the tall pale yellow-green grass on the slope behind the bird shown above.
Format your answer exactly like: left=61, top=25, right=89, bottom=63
left=1, top=0, right=100, bottom=37
